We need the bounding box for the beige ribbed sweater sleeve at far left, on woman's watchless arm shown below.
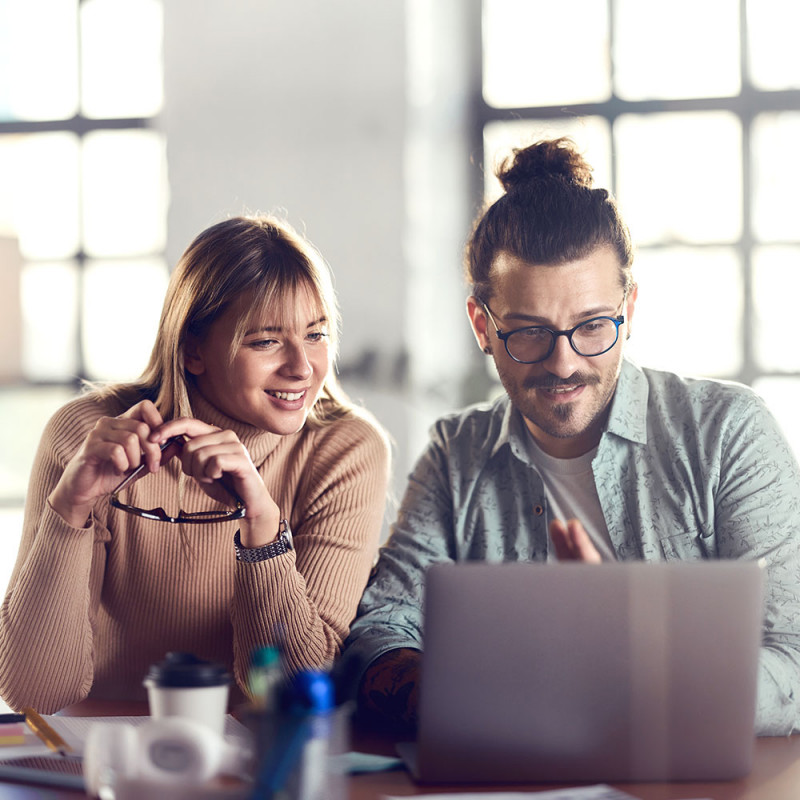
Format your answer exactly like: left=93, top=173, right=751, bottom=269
left=0, top=398, right=112, bottom=713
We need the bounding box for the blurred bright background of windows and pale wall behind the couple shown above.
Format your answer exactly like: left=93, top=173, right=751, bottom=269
left=0, top=0, right=800, bottom=586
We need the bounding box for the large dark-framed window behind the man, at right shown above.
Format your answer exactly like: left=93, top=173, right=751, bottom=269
left=478, top=0, right=800, bottom=453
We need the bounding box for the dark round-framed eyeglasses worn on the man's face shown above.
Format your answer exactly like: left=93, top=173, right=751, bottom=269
left=482, top=292, right=628, bottom=364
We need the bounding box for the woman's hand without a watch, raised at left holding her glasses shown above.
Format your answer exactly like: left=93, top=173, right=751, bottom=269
left=49, top=400, right=167, bottom=528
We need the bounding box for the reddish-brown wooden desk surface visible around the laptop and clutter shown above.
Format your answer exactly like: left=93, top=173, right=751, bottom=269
left=0, top=701, right=800, bottom=800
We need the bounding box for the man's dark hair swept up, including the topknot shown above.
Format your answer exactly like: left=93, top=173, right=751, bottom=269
left=465, top=137, right=633, bottom=301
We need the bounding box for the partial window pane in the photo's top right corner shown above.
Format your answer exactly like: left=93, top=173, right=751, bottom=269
left=747, top=0, right=800, bottom=89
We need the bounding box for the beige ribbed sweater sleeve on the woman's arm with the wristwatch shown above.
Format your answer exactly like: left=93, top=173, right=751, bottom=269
left=232, top=417, right=389, bottom=686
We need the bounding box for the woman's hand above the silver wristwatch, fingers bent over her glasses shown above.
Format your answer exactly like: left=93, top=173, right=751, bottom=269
left=150, top=417, right=281, bottom=547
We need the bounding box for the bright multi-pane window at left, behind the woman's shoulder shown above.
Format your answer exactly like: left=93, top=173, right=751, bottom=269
left=0, top=0, right=168, bottom=585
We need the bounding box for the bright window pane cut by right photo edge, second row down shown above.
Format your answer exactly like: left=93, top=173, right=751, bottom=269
left=751, top=112, right=800, bottom=241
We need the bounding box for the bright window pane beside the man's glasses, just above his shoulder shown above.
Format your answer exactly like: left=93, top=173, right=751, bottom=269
left=628, top=247, right=743, bottom=377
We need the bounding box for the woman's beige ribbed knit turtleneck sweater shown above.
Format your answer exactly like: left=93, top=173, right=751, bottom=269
left=0, top=394, right=389, bottom=713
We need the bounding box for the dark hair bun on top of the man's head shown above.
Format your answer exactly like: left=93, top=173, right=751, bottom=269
left=496, top=136, right=592, bottom=192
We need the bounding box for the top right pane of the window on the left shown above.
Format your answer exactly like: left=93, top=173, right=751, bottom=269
left=81, top=0, right=163, bottom=118
